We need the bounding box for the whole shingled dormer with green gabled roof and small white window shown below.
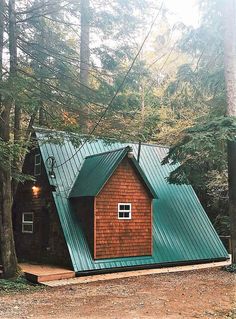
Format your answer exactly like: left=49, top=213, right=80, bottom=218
left=69, top=147, right=157, bottom=259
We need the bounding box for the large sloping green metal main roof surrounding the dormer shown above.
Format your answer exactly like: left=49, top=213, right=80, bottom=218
left=36, top=130, right=228, bottom=272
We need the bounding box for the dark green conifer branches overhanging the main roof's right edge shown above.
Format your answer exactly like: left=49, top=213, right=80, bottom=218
left=163, top=117, right=236, bottom=187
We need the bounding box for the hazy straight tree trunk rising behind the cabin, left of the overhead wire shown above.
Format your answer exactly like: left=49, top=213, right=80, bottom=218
left=79, top=0, right=90, bottom=132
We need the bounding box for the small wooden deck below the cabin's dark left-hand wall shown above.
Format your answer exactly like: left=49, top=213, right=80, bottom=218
left=19, top=263, right=75, bottom=283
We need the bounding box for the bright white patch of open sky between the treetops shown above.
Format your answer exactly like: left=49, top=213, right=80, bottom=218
left=164, top=0, right=199, bottom=27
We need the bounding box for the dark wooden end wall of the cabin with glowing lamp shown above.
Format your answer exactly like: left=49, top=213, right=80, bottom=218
left=13, top=150, right=71, bottom=266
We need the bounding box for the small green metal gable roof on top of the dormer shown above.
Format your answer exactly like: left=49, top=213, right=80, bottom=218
left=69, top=146, right=157, bottom=198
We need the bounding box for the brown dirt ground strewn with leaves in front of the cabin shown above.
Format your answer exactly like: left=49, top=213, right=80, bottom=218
left=0, top=269, right=236, bottom=319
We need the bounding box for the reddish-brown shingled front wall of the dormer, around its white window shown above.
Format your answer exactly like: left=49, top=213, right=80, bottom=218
left=94, top=158, right=152, bottom=259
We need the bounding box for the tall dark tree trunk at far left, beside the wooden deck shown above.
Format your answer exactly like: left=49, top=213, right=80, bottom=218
left=0, top=0, right=17, bottom=278
